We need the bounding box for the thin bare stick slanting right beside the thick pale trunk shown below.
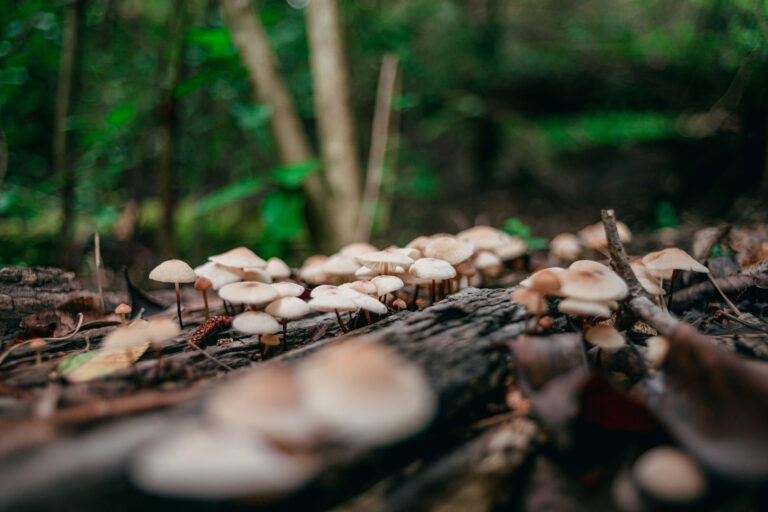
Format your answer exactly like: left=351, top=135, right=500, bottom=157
left=355, top=53, right=397, bottom=240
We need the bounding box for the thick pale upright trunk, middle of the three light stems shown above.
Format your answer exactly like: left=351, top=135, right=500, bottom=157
left=305, top=0, right=361, bottom=243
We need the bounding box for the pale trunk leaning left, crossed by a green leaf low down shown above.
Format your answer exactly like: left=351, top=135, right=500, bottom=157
left=221, top=0, right=345, bottom=250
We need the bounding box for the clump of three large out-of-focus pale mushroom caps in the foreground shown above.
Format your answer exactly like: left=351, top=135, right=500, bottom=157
left=131, top=338, right=437, bottom=499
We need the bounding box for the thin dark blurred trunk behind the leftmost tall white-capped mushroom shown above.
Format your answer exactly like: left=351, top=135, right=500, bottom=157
left=157, top=0, right=186, bottom=258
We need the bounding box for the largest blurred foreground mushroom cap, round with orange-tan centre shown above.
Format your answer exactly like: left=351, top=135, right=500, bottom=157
left=299, top=340, right=437, bottom=445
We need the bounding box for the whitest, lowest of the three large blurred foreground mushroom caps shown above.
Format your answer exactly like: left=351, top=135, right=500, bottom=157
left=130, top=427, right=318, bottom=500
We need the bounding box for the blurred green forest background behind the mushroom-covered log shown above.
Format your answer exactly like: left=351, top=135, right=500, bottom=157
left=0, top=0, right=768, bottom=274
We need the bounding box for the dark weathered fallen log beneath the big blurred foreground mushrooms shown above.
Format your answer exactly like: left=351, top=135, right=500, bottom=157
left=0, top=288, right=523, bottom=510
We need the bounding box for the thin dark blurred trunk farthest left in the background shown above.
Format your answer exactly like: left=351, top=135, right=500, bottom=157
left=53, top=0, right=84, bottom=266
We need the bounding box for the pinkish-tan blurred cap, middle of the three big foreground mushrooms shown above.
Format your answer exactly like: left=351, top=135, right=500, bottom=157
left=206, top=366, right=318, bottom=445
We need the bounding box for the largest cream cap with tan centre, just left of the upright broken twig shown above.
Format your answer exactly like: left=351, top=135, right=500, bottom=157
left=558, top=260, right=629, bottom=301
